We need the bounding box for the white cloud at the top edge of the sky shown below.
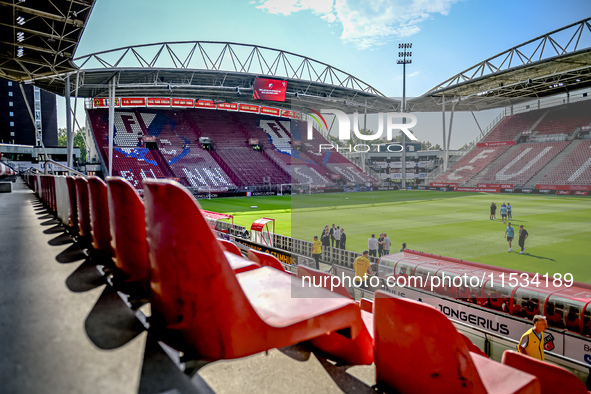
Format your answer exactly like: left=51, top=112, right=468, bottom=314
left=257, top=0, right=460, bottom=49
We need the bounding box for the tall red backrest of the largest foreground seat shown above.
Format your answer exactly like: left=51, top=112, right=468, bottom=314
left=144, top=179, right=256, bottom=344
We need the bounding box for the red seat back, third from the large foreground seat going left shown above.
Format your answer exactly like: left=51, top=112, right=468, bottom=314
left=88, top=176, right=113, bottom=256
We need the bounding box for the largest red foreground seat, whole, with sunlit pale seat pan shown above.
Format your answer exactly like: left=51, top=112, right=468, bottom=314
left=144, top=179, right=364, bottom=360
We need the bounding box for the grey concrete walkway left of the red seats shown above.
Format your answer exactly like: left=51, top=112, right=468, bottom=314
left=0, top=179, right=146, bottom=394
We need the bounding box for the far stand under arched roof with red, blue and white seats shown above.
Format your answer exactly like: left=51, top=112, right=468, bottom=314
left=88, top=108, right=375, bottom=191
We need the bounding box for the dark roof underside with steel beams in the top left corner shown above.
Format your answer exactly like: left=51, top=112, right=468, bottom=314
left=0, top=0, right=95, bottom=87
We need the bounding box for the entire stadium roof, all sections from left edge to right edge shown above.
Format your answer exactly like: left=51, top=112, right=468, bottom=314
left=0, top=5, right=591, bottom=113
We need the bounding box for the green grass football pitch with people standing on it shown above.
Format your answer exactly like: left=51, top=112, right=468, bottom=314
left=200, top=191, right=591, bottom=283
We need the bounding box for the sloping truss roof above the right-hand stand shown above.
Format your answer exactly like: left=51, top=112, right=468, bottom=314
left=407, top=18, right=591, bottom=111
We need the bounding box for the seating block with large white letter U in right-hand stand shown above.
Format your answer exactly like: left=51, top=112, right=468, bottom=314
left=480, top=141, right=569, bottom=185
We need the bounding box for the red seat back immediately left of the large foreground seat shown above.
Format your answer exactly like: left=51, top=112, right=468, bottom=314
left=107, top=177, right=150, bottom=289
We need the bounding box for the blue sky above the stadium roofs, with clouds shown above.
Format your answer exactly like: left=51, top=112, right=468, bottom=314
left=58, top=0, right=591, bottom=146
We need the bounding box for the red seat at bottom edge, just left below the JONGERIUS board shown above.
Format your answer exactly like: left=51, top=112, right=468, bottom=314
left=374, top=291, right=540, bottom=394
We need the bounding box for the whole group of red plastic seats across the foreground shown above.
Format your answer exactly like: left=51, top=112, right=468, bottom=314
left=22, top=176, right=586, bottom=394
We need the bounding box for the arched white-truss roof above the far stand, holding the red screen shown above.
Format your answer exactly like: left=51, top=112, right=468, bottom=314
left=36, top=41, right=400, bottom=113
